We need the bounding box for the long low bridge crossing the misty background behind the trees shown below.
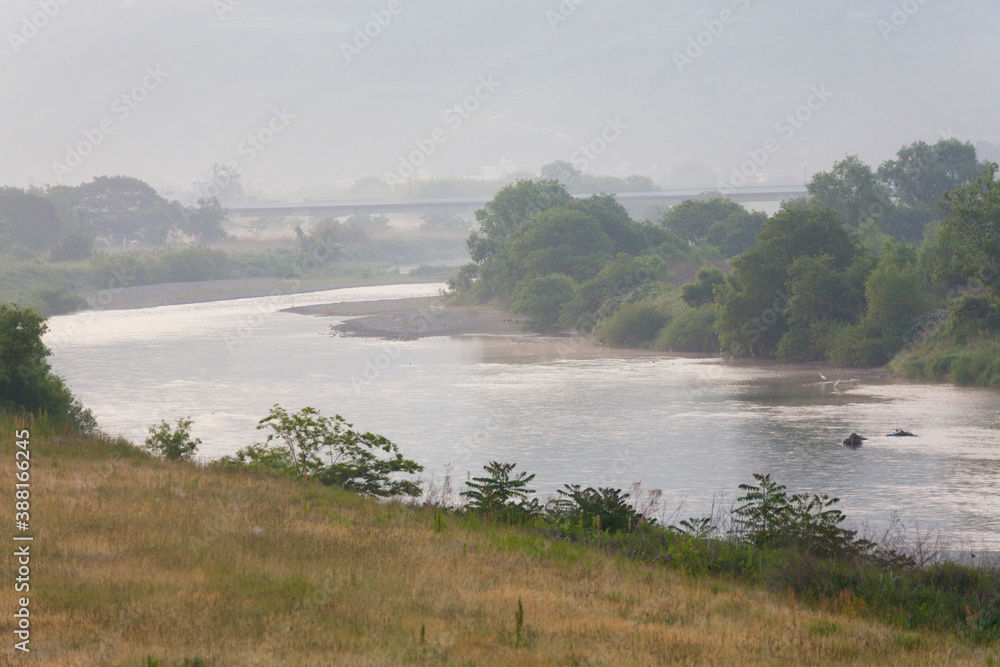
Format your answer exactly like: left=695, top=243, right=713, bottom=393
left=229, top=185, right=806, bottom=218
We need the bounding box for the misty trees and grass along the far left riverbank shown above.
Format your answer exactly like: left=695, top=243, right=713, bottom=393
left=0, top=176, right=468, bottom=315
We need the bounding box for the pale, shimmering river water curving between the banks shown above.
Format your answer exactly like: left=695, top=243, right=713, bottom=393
left=45, top=284, right=1000, bottom=550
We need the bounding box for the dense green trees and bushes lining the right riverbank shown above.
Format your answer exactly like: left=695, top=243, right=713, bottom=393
left=449, top=139, right=1000, bottom=386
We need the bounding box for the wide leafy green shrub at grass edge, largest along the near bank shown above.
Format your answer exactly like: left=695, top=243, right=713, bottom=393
left=221, top=405, right=424, bottom=497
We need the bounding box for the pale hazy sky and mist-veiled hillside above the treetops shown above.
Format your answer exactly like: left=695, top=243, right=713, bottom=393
left=0, top=0, right=1000, bottom=194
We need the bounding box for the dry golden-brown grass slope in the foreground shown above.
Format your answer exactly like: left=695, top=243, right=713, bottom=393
left=0, top=433, right=998, bottom=666
